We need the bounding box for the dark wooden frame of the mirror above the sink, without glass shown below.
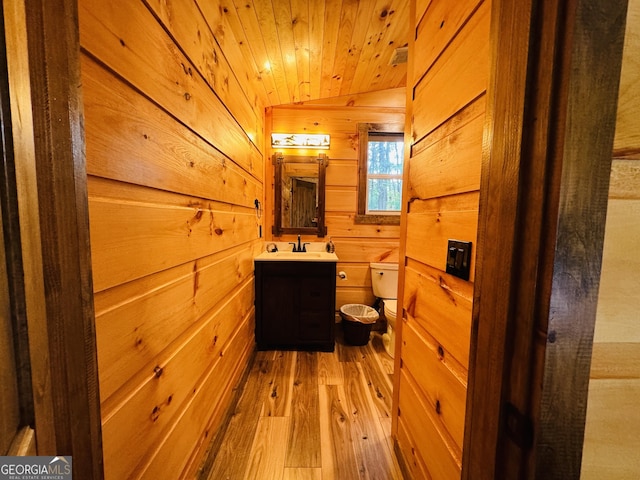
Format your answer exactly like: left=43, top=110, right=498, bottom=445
left=272, top=152, right=329, bottom=237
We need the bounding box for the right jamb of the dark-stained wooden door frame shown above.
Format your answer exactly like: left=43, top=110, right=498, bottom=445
left=462, top=0, right=627, bottom=480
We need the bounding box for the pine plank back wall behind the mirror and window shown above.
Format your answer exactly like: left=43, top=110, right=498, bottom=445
left=265, top=88, right=405, bottom=310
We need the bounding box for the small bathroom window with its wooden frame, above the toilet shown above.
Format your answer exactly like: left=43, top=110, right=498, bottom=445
left=356, top=123, right=404, bottom=223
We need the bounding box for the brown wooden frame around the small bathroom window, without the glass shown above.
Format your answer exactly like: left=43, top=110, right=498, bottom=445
left=355, top=123, right=406, bottom=225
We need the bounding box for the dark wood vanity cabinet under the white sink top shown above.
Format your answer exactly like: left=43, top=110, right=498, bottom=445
left=255, top=261, right=336, bottom=351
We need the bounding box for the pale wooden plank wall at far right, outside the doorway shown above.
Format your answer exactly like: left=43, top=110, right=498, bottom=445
left=581, top=0, right=640, bottom=474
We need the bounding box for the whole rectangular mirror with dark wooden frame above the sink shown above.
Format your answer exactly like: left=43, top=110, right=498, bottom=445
left=273, top=153, right=328, bottom=237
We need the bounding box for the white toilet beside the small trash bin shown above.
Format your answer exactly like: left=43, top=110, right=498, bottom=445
left=369, top=263, right=398, bottom=357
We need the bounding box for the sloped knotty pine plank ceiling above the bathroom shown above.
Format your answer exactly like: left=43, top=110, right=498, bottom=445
left=216, top=0, right=409, bottom=106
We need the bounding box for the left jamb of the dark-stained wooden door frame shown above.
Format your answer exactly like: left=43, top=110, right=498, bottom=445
left=3, top=0, right=104, bottom=480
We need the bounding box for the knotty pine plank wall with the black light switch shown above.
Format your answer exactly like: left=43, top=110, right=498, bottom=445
left=394, top=0, right=491, bottom=480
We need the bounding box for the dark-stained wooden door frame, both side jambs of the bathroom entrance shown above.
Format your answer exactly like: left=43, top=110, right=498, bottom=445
left=2, top=0, right=627, bottom=479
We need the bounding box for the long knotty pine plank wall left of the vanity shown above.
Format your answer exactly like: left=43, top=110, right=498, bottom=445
left=79, top=0, right=264, bottom=479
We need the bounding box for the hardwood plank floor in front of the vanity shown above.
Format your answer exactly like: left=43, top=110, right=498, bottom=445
left=200, top=325, right=403, bottom=480
